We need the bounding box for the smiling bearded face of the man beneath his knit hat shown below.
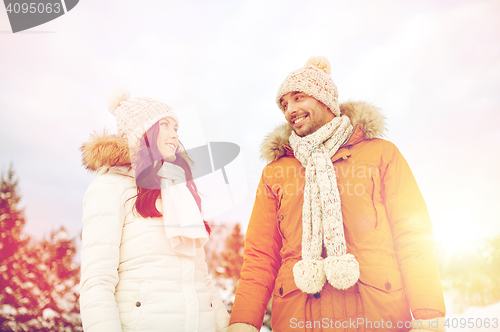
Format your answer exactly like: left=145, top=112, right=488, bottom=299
left=280, top=91, right=335, bottom=137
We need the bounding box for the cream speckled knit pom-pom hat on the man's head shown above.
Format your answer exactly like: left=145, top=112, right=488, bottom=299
left=276, top=56, right=340, bottom=116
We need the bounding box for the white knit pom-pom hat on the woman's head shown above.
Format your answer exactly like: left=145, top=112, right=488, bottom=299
left=108, top=89, right=179, bottom=144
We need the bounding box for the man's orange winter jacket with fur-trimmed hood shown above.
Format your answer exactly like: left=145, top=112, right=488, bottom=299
left=230, top=102, right=445, bottom=331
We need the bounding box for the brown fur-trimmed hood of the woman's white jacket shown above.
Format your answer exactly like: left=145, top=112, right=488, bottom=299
left=80, top=131, right=131, bottom=172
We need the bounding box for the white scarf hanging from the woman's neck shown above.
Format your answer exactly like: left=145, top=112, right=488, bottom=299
left=158, top=162, right=208, bottom=256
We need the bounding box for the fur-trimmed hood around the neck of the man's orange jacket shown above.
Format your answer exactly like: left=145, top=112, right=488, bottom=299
left=261, top=101, right=385, bottom=162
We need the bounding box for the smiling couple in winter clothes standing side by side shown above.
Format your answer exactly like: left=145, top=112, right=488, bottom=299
left=80, top=57, right=445, bottom=332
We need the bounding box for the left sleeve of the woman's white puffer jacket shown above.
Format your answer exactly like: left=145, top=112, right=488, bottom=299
left=80, top=174, right=125, bottom=332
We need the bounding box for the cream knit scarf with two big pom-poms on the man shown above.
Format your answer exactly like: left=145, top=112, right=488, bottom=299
left=290, top=115, right=359, bottom=294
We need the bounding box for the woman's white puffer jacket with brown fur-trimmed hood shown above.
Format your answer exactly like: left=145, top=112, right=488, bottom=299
left=80, top=135, right=229, bottom=332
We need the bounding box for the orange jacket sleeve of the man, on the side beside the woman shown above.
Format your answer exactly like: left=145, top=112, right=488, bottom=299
left=230, top=171, right=282, bottom=329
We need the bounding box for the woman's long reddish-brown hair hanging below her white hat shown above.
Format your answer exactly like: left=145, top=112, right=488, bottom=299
left=134, top=121, right=210, bottom=234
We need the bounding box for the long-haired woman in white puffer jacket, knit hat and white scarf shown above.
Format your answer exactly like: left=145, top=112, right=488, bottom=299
left=80, top=92, right=229, bottom=332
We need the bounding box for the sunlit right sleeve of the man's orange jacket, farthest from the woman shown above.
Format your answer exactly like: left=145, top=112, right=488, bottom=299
left=382, top=145, right=446, bottom=315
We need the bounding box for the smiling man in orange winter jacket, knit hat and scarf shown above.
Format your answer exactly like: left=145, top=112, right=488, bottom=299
left=229, top=57, right=445, bottom=332
